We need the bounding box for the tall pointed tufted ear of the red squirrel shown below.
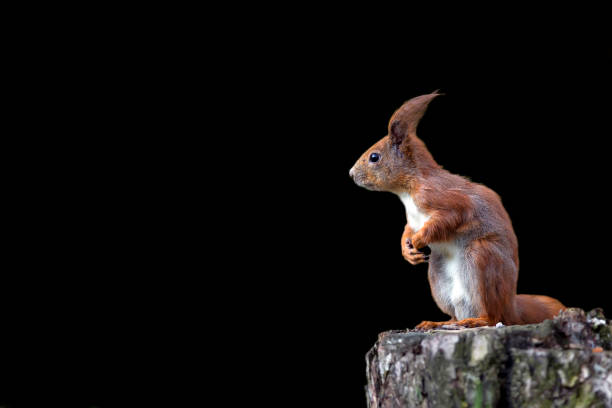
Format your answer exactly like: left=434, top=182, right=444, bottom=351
left=389, top=91, right=442, bottom=146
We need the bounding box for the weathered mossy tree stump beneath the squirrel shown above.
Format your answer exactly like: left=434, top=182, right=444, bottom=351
left=366, top=309, right=612, bottom=408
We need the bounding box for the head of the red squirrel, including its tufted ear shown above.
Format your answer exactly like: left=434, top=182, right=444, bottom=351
left=349, top=91, right=440, bottom=193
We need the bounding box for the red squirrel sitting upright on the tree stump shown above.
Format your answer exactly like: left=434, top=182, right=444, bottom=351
left=349, top=92, right=565, bottom=330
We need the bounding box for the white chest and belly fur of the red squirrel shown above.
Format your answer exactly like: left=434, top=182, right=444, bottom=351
left=400, top=194, right=474, bottom=319
